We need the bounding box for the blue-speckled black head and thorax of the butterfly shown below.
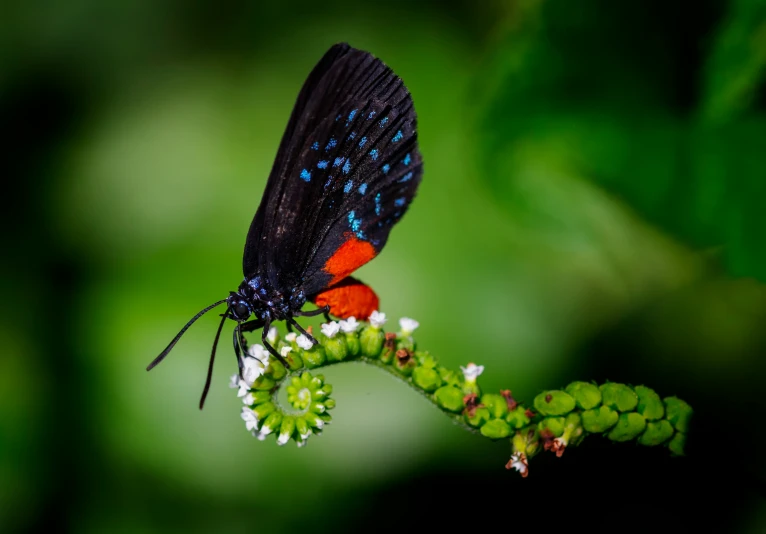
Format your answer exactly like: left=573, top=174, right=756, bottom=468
left=227, top=276, right=306, bottom=322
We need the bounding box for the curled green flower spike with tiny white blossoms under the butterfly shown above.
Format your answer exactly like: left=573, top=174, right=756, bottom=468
left=229, top=311, right=692, bottom=477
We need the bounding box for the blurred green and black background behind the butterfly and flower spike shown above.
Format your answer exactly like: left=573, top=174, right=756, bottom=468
left=0, top=0, right=766, bottom=534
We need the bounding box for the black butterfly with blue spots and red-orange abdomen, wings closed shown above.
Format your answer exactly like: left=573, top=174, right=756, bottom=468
left=147, top=43, right=423, bottom=409
